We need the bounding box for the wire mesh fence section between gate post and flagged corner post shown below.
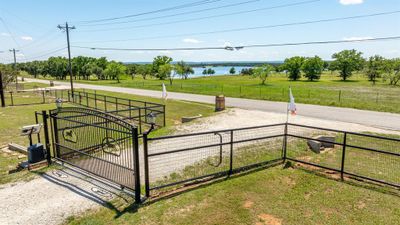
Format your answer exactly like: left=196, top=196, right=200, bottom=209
left=144, top=124, right=284, bottom=195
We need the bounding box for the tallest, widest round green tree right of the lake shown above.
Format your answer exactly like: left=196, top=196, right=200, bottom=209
left=330, top=49, right=365, bottom=81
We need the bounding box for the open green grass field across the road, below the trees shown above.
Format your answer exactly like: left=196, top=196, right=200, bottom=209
left=67, top=73, right=400, bottom=113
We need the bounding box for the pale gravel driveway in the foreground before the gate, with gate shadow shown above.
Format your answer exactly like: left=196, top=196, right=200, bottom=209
left=0, top=166, right=128, bottom=225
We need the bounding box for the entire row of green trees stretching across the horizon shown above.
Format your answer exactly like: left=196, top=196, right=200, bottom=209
left=3, top=49, right=400, bottom=85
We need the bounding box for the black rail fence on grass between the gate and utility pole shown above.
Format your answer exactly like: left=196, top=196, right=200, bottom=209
left=68, top=91, right=165, bottom=133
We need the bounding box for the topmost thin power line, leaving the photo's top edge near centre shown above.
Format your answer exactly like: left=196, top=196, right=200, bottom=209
left=76, top=0, right=222, bottom=23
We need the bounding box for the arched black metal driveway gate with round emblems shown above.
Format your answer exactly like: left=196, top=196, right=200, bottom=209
left=50, top=107, right=140, bottom=201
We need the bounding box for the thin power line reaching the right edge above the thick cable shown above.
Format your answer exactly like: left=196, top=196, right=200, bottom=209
left=75, top=10, right=400, bottom=43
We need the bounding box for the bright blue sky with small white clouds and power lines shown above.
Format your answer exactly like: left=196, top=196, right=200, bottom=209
left=0, top=0, right=400, bottom=63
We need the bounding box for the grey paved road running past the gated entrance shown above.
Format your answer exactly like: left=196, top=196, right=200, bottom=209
left=26, top=79, right=400, bottom=131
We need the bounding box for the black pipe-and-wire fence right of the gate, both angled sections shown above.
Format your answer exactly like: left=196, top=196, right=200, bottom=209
left=142, top=123, right=400, bottom=196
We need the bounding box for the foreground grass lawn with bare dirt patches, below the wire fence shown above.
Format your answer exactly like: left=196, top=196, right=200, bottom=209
left=66, top=166, right=400, bottom=225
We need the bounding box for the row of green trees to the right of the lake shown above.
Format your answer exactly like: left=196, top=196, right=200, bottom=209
left=241, top=49, right=400, bottom=85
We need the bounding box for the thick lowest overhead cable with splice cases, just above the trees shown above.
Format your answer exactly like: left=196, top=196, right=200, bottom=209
left=71, top=36, right=400, bottom=51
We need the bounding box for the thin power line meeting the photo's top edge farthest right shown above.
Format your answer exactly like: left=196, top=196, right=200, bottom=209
left=82, top=0, right=321, bottom=32
